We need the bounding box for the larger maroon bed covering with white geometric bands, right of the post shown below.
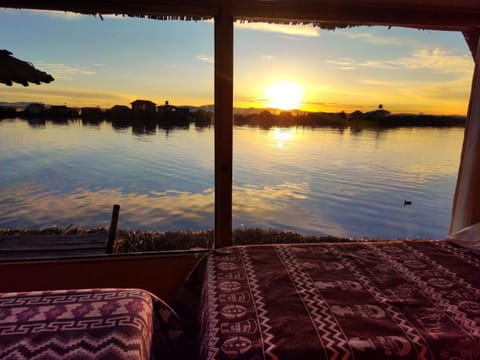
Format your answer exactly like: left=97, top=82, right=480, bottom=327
left=191, top=241, right=480, bottom=360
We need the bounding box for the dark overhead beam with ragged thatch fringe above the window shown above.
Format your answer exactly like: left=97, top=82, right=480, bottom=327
left=0, top=0, right=480, bottom=31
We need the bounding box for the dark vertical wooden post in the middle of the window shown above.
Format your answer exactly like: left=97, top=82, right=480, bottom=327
left=215, top=1, right=233, bottom=247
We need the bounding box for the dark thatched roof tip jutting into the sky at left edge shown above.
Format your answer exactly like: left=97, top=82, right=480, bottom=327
left=0, top=50, right=53, bottom=86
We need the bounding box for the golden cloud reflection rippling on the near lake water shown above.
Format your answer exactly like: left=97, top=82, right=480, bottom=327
left=0, top=182, right=340, bottom=236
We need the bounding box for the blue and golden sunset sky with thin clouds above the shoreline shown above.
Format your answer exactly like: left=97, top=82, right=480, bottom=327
left=0, top=8, right=474, bottom=115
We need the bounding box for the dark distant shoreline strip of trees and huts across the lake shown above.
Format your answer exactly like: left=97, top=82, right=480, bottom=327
left=0, top=104, right=466, bottom=129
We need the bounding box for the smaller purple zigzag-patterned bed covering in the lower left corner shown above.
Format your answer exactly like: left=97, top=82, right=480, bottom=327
left=0, top=289, right=190, bottom=360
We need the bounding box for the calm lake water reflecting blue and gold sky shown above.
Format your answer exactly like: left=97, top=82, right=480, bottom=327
left=0, top=119, right=463, bottom=238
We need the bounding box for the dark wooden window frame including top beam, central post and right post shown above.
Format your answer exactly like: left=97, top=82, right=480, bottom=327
left=0, top=0, right=480, bottom=247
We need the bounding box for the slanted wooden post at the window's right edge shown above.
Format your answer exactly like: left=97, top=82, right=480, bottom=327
left=450, top=37, right=480, bottom=234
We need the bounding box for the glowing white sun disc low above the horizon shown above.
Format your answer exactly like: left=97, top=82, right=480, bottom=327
left=263, top=81, right=305, bottom=110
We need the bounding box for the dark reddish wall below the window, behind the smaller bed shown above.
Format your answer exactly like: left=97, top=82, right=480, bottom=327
left=0, top=253, right=204, bottom=304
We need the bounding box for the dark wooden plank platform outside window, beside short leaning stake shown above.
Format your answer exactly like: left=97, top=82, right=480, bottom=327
left=0, top=232, right=108, bottom=261
